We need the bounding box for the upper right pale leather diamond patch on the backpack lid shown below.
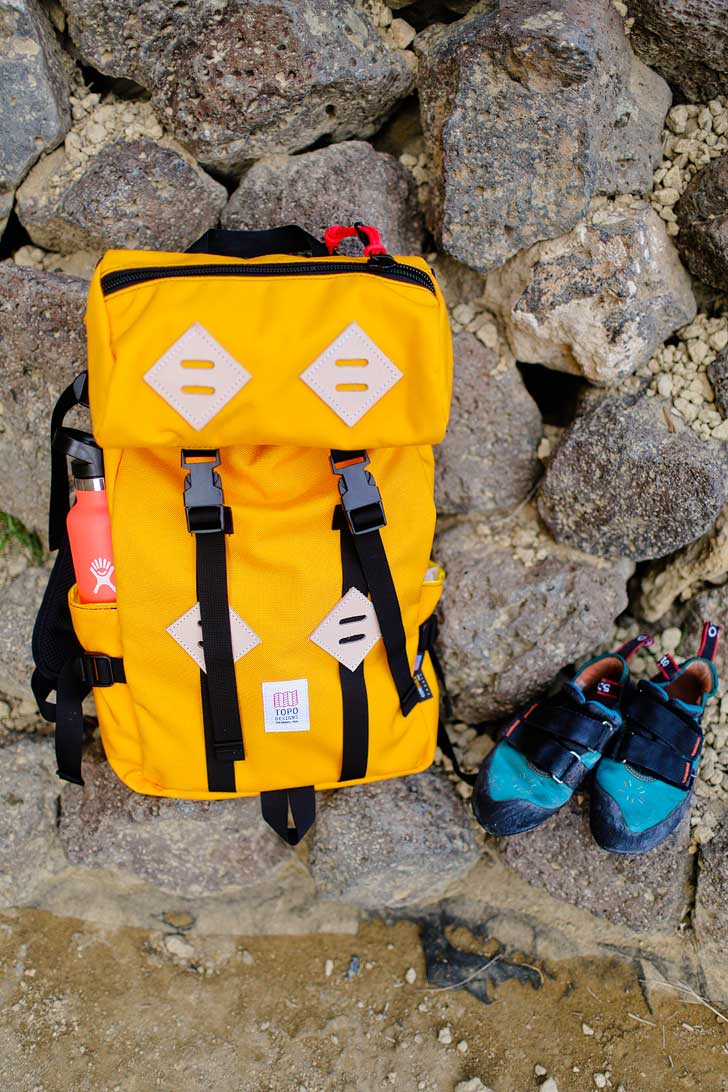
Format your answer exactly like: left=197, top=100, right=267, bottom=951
left=300, top=322, right=402, bottom=425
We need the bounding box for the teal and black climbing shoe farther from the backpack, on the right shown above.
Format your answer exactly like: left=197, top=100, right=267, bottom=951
left=590, top=622, right=720, bottom=854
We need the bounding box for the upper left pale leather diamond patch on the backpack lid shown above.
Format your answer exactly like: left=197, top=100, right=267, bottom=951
left=144, top=322, right=251, bottom=430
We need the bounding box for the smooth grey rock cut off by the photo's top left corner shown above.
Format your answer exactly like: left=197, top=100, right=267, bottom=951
left=0, top=0, right=71, bottom=234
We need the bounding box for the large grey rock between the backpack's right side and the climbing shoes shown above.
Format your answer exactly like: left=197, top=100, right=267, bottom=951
left=437, top=509, right=632, bottom=724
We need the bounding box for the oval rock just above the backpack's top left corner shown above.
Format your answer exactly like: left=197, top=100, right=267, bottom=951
left=17, top=140, right=227, bottom=254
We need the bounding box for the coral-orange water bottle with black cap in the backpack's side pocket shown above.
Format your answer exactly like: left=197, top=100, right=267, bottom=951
left=65, top=429, right=117, bottom=603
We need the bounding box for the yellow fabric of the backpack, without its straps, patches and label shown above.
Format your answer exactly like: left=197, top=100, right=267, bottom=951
left=70, top=251, right=451, bottom=799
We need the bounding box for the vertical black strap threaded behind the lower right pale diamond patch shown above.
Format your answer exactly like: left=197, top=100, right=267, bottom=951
left=333, top=505, right=369, bottom=781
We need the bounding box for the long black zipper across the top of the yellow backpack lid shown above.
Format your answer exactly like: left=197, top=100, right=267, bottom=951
left=102, top=254, right=434, bottom=296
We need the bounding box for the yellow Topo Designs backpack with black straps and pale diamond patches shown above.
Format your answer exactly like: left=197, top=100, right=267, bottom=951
left=33, top=225, right=452, bottom=844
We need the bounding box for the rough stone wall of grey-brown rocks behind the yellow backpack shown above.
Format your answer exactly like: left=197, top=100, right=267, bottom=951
left=0, top=0, right=728, bottom=982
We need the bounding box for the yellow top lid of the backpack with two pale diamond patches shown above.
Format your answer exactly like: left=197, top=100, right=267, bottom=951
left=86, top=250, right=452, bottom=450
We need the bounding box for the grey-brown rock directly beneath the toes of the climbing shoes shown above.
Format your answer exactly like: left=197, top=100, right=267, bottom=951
left=501, top=797, right=691, bottom=933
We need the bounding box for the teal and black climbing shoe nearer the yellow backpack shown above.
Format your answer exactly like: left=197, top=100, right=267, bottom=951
left=473, top=634, right=652, bottom=835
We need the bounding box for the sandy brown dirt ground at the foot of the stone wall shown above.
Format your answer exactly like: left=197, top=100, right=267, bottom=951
left=0, top=910, right=728, bottom=1092
